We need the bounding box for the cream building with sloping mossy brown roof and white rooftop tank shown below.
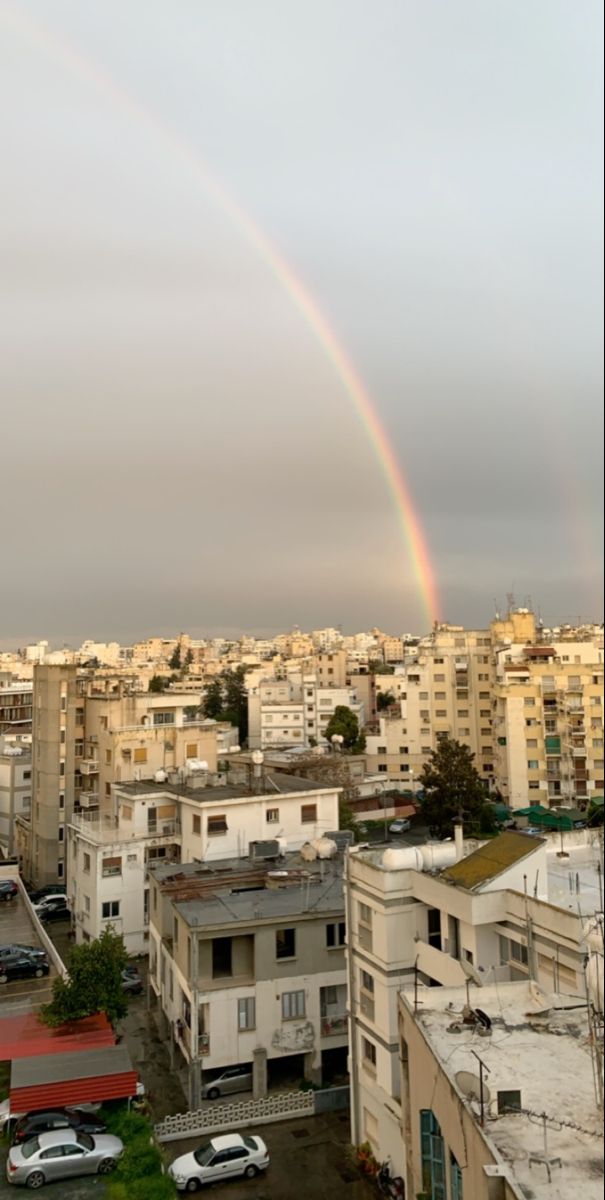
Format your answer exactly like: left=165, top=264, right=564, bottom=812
left=346, top=828, right=600, bottom=1176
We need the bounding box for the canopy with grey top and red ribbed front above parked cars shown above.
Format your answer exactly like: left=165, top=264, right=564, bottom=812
left=10, top=1045, right=137, bottom=1112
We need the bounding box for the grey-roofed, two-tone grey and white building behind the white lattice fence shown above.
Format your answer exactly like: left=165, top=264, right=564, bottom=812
left=149, top=854, right=347, bottom=1109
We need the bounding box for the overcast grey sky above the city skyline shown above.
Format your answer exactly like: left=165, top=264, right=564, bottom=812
left=0, top=0, right=603, bottom=646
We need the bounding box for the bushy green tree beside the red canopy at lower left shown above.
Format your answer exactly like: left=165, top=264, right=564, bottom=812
left=41, top=928, right=128, bottom=1026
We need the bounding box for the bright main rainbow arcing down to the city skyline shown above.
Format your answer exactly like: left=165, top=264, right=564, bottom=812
left=0, top=0, right=439, bottom=624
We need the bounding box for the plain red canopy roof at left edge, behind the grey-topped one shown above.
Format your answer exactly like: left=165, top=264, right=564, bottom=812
left=0, top=1013, right=115, bottom=1062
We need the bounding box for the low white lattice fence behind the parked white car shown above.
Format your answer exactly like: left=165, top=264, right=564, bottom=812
left=154, top=1091, right=315, bottom=1141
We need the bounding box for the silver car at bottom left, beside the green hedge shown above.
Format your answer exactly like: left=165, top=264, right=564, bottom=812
left=6, top=1129, right=124, bottom=1188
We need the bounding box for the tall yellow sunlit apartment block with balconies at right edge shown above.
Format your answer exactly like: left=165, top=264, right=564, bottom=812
left=493, top=640, right=605, bottom=809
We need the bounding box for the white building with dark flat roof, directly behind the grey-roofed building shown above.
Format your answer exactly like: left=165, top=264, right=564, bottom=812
left=67, top=770, right=340, bottom=954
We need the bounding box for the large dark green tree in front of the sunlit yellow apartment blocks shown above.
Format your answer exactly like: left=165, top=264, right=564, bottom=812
left=419, top=737, right=495, bottom=836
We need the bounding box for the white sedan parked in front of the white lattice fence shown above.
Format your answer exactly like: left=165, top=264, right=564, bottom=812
left=168, top=1133, right=269, bottom=1192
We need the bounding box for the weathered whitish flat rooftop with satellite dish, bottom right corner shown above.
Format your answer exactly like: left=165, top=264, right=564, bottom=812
left=403, top=983, right=604, bottom=1200
